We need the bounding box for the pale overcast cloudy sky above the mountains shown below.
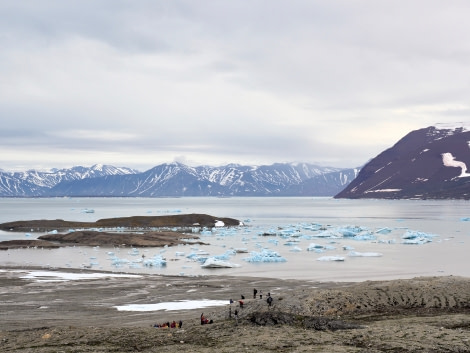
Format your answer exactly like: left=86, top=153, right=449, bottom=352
left=0, top=0, right=470, bottom=171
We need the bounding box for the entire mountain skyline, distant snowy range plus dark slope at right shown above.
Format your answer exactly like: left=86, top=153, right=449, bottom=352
left=4, top=123, right=470, bottom=200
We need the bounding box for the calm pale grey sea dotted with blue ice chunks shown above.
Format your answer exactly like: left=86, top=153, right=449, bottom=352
left=0, top=197, right=470, bottom=281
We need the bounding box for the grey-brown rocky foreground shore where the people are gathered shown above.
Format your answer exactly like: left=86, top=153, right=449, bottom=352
left=0, top=268, right=470, bottom=353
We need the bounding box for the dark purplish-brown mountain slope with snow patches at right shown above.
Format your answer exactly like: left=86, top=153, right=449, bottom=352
left=335, top=126, right=470, bottom=200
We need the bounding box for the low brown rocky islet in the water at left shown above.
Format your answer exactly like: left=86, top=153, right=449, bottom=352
left=0, top=213, right=241, bottom=250
